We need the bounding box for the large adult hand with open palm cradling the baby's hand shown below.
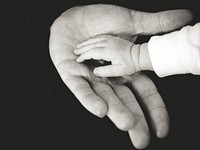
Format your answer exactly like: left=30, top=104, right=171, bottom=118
left=49, top=5, right=191, bottom=149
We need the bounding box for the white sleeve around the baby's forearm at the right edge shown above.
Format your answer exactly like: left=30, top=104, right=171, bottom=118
left=148, top=23, right=200, bottom=77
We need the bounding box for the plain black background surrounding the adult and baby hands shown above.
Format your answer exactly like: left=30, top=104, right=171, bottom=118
left=3, top=0, right=200, bottom=150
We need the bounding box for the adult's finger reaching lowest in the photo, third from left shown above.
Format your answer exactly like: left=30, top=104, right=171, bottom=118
left=114, top=86, right=150, bottom=149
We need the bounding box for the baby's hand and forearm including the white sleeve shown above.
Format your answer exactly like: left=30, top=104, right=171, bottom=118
left=74, top=23, right=200, bottom=77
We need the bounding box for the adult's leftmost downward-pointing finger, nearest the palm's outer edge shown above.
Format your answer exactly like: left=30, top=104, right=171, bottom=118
left=56, top=61, right=108, bottom=117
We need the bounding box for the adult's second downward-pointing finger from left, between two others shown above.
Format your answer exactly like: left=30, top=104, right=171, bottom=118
left=92, top=82, right=135, bottom=131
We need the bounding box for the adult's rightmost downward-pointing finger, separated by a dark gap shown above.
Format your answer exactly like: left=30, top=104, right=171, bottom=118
left=132, top=74, right=169, bottom=138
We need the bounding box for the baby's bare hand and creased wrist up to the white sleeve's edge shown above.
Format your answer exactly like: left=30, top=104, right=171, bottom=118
left=74, top=35, right=153, bottom=77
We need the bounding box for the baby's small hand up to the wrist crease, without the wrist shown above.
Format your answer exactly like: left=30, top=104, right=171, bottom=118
left=74, top=35, right=137, bottom=77
